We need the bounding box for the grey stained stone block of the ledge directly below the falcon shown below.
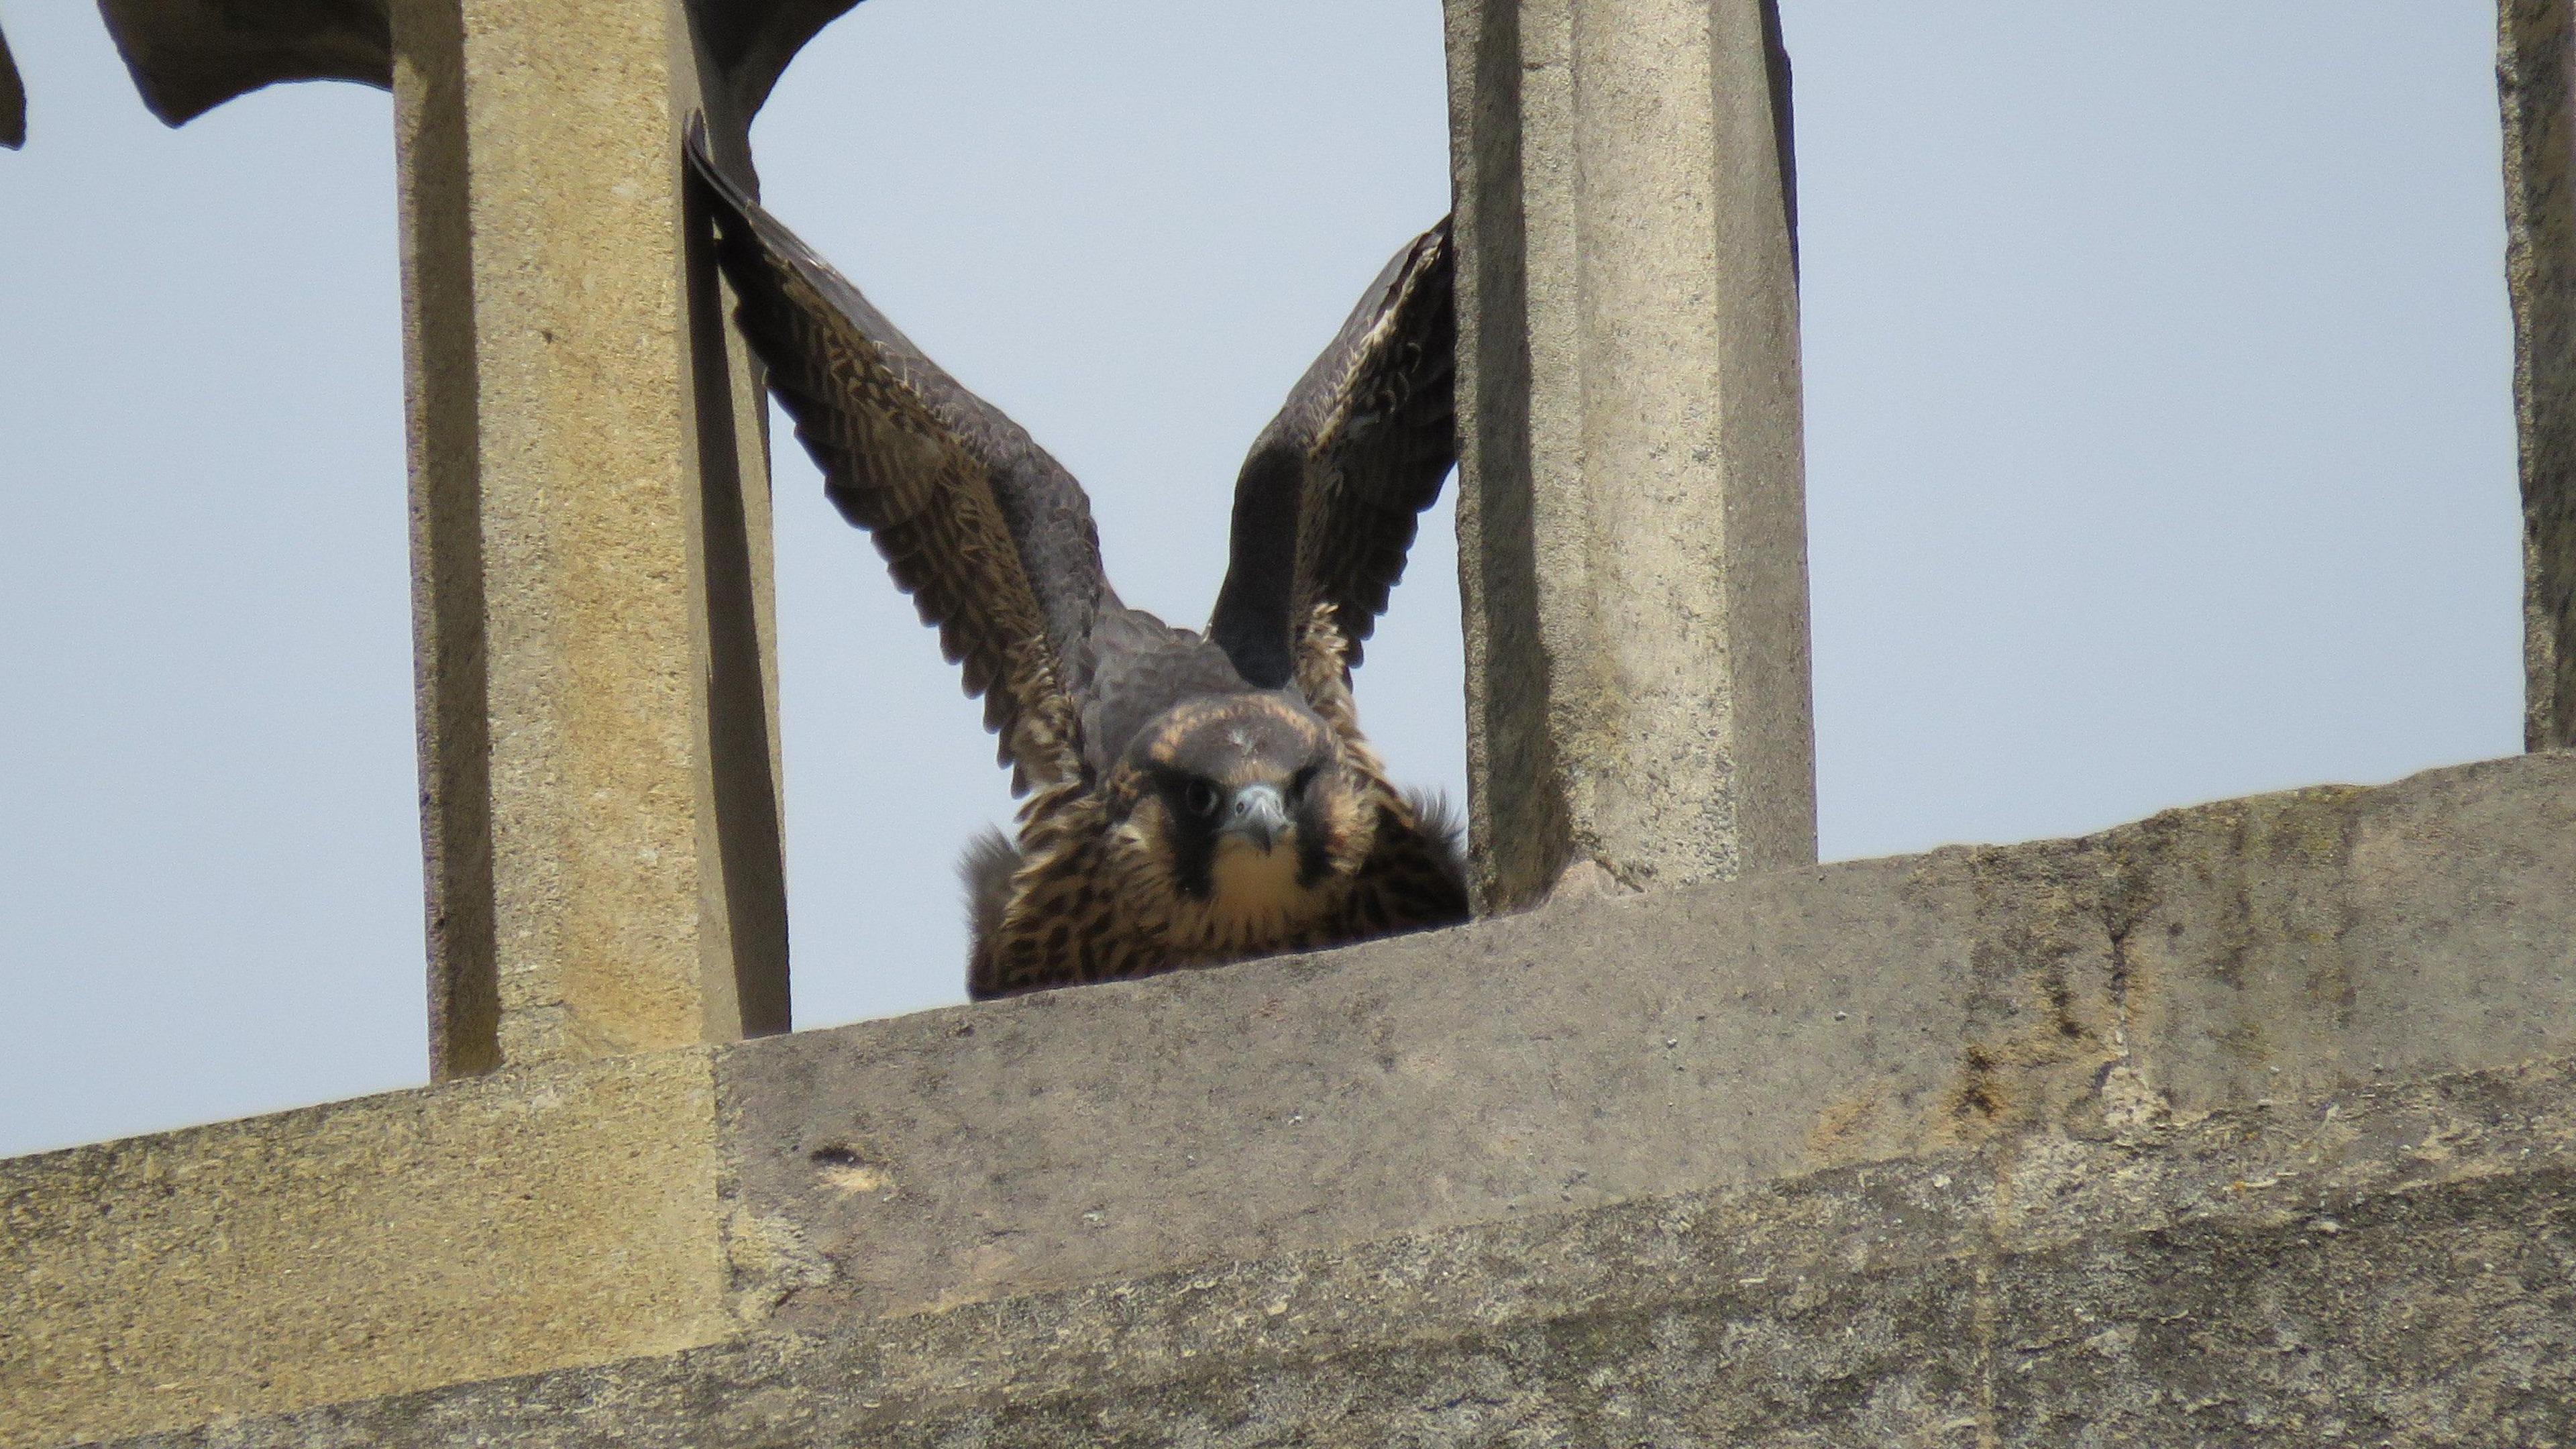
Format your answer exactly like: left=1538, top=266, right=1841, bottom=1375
left=718, top=755, right=2576, bottom=1320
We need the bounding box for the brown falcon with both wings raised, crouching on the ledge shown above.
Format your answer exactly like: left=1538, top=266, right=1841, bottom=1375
left=690, top=129, right=1468, bottom=998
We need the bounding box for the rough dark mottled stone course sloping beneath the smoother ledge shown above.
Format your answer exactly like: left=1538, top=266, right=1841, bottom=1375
left=100, top=1041, right=2576, bottom=1449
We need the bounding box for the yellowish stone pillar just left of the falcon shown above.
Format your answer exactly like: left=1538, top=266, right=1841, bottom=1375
left=392, top=0, right=788, bottom=1078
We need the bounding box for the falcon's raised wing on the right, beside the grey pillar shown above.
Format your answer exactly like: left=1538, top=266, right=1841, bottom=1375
left=1208, top=217, right=1458, bottom=688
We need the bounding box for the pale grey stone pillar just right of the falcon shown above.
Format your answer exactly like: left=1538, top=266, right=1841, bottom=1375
left=1448, top=0, right=1816, bottom=910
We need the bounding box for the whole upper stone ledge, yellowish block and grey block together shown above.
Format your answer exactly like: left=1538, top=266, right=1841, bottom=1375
left=0, top=755, right=2576, bottom=1446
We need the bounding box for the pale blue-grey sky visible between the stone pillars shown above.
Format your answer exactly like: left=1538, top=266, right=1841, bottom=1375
left=0, top=0, right=2520, bottom=1155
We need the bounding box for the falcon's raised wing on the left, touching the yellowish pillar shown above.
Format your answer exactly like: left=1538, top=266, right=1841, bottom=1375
left=688, top=123, right=1118, bottom=789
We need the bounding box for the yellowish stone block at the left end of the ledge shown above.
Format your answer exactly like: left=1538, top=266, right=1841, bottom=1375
left=0, top=1052, right=729, bottom=1446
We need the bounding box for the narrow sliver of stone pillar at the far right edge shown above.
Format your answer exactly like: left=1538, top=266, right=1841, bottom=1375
left=2496, top=0, right=2576, bottom=750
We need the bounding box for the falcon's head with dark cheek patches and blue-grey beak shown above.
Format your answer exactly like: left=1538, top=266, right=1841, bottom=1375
left=1118, top=691, right=1376, bottom=933
